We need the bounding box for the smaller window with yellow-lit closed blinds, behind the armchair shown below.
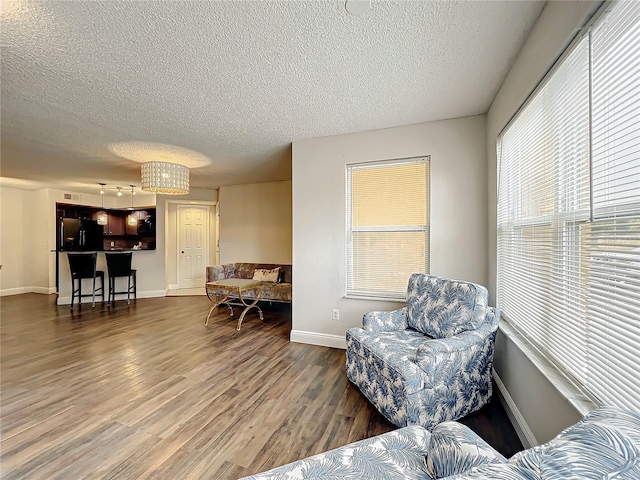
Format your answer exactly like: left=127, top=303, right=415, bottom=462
left=346, top=157, right=429, bottom=299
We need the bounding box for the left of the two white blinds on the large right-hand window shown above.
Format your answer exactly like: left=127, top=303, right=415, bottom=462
left=498, top=35, right=589, bottom=382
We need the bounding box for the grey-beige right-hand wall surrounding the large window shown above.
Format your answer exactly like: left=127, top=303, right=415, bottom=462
left=487, top=1, right=602, bottom=443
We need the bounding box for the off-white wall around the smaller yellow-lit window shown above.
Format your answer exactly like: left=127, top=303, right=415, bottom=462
left=292, top=116, right=487, bottom=348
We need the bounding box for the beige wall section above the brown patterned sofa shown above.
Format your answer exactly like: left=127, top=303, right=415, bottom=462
left=219, top=180, right=292, bottom=264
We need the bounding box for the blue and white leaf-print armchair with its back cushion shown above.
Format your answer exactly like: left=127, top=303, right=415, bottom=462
left=346, top=273, right=500, bottom=430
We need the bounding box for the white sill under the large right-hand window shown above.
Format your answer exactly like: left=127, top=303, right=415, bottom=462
left=500, top=319, right=598, bottom=415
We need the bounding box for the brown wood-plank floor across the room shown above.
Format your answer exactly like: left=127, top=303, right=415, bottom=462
left=0, top=294, right=522, bottom=479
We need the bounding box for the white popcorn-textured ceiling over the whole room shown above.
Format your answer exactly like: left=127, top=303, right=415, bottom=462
left=0, top=0, right=544, bottom=189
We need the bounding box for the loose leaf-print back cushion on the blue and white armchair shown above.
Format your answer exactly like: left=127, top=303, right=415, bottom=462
left=407, top=273, right=489, bottom=338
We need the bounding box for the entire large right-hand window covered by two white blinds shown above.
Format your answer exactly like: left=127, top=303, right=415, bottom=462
left=497, top=2, right=640, bottom=409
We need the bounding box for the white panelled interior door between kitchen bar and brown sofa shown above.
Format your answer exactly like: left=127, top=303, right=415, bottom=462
left=178, top=205, right=210, bottom=288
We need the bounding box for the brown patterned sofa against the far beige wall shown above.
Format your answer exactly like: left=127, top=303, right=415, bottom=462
left=207, top=263, right=291, bottom=303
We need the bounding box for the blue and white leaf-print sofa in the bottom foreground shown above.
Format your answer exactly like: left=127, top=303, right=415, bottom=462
left=243, top=407, right=640, bottom=480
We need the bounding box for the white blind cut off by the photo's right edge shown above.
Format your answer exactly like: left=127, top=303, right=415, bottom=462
left=584, top=2, right=640, bottom=409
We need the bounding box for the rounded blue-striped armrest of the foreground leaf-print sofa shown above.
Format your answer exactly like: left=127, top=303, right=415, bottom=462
left=425, top=422, right=507, bottom=478
